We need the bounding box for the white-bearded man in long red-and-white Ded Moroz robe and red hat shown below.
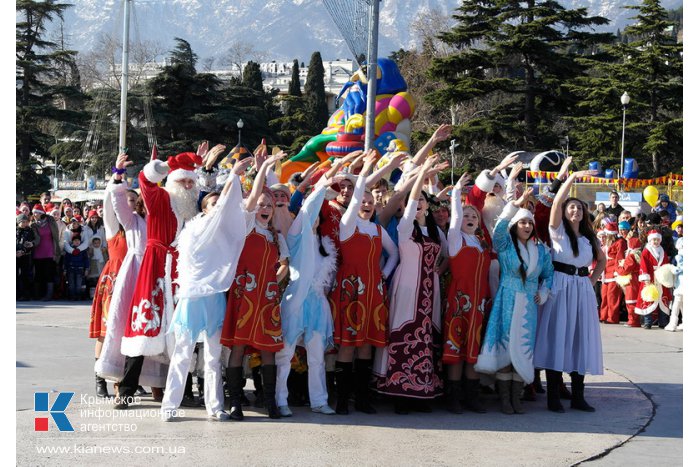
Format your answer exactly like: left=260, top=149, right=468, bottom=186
left=116, top=152, right=202, bottom=409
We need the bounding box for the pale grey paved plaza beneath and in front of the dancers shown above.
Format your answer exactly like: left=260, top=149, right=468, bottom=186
left=17, top=302, right=683, bottom=466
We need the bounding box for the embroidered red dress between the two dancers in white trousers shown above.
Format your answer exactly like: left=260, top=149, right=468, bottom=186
left=221, top=229, right=284, bottom=352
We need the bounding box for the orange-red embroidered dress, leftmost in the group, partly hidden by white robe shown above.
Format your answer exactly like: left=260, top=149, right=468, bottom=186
left=90, top=230, right=128, bottom=339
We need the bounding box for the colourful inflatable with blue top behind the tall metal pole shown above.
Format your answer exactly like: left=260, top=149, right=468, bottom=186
left=280, top=58, right=416, bottom=182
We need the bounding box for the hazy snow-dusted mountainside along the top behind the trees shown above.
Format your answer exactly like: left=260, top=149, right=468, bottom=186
left=41, top=0, right=682, bottom=61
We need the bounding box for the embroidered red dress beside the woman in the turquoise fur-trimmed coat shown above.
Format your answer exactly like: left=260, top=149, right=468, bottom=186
left=442, top=240, right=491, bottom=365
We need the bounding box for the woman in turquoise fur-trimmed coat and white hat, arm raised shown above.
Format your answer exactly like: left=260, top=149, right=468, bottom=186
left=474, top=189, right=554, bottom=414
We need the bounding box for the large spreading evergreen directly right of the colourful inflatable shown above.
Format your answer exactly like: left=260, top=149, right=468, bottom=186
left=430, top=0, right=613, bottom=161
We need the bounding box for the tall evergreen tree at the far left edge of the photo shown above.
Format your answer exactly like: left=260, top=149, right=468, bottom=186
left=15, top=0, right=84, bottom=195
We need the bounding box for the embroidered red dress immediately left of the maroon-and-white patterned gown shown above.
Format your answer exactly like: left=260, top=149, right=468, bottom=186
left=329, top=226, right=389, bottom=347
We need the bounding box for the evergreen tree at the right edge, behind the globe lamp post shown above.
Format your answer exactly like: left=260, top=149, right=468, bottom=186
left=570, top=0, right=683, bottom=176
